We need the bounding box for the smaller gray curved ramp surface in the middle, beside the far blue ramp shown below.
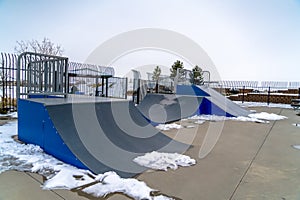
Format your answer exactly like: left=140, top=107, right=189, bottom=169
left=137, top=94, right=203, bottom=124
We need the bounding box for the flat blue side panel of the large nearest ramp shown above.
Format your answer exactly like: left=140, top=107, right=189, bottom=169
left=18, top=99, right=87, bottom=169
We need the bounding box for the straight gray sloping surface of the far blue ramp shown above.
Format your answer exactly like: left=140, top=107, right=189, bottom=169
left=197, top=86, right=251, bottom=116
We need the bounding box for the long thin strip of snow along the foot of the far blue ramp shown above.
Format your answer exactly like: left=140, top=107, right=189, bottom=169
left=188, top=112, right=287, bottom=124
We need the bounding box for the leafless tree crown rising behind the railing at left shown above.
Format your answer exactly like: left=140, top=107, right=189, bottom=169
left=15, top=37, right=64, bottom=56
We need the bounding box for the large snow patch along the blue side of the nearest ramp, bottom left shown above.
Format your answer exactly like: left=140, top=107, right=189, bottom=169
left=0, top=122, right=176, bottom=200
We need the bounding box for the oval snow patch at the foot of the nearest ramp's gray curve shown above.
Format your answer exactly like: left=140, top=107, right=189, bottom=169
left=133, top=151, right=196, bottom=171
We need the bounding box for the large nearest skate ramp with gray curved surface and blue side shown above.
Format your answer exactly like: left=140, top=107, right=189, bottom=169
left=18, top=97, right=189, bottom=177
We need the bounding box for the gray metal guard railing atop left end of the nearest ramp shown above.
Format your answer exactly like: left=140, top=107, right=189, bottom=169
left=16, top=52, right=69, bottom=99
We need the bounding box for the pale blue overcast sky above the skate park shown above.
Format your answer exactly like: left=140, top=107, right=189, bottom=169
left=0, top=0, right=300, bottom=81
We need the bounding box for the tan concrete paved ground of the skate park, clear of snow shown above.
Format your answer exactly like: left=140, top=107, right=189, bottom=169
left=0, top=108, right=300, bottom=200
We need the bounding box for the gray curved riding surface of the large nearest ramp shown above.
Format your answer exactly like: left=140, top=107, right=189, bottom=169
left=45, top=97, right=189, bottom=177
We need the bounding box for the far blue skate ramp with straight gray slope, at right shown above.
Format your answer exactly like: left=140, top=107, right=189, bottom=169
left=177, top=85, right=251, bottom=117
